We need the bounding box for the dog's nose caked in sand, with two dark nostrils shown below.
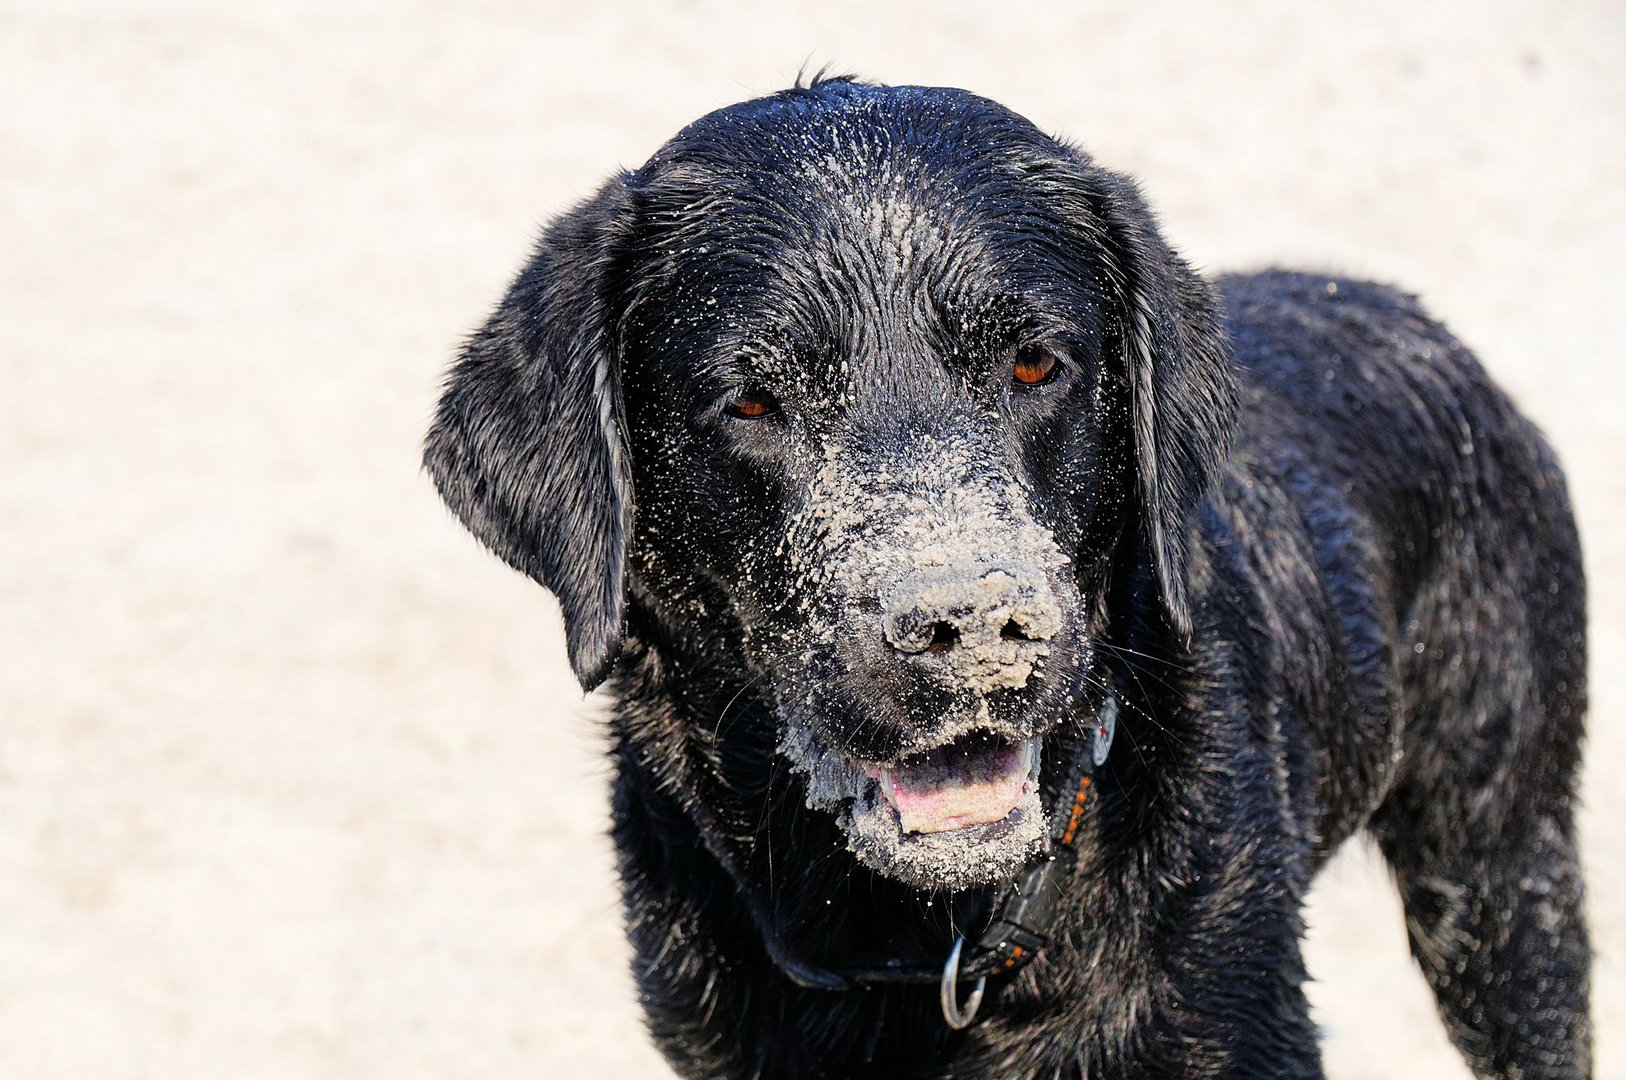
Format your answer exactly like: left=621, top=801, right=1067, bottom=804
left=881, top=566, right=1062, bottom=668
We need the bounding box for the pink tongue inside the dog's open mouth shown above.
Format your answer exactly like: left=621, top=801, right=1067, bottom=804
left=881, top=747, right=1028, bottom=833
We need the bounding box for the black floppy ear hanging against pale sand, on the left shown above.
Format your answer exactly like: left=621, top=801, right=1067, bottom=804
left=424, top=174, right=633, bottom=690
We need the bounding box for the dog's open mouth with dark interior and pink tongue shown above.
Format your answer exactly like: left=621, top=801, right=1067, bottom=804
left=860, top=732, right=1039, bottom=836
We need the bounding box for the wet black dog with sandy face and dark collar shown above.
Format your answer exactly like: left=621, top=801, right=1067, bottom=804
left=428, top=80, right=1590, bottom=1080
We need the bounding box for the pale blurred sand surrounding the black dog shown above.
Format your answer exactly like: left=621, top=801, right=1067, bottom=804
left=0, top=0, right=1626, bottom=1080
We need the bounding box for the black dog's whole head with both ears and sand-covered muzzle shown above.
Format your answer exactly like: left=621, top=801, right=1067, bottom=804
left=428, top=80, right=1234, bottom=888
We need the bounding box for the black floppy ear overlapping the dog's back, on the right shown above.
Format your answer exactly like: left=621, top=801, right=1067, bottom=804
left=1089, top=169, right=1237, bottom=638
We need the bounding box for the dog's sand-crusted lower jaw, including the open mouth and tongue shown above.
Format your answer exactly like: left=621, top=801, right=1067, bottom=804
left=780, top=722, right=1049, bottom=891
